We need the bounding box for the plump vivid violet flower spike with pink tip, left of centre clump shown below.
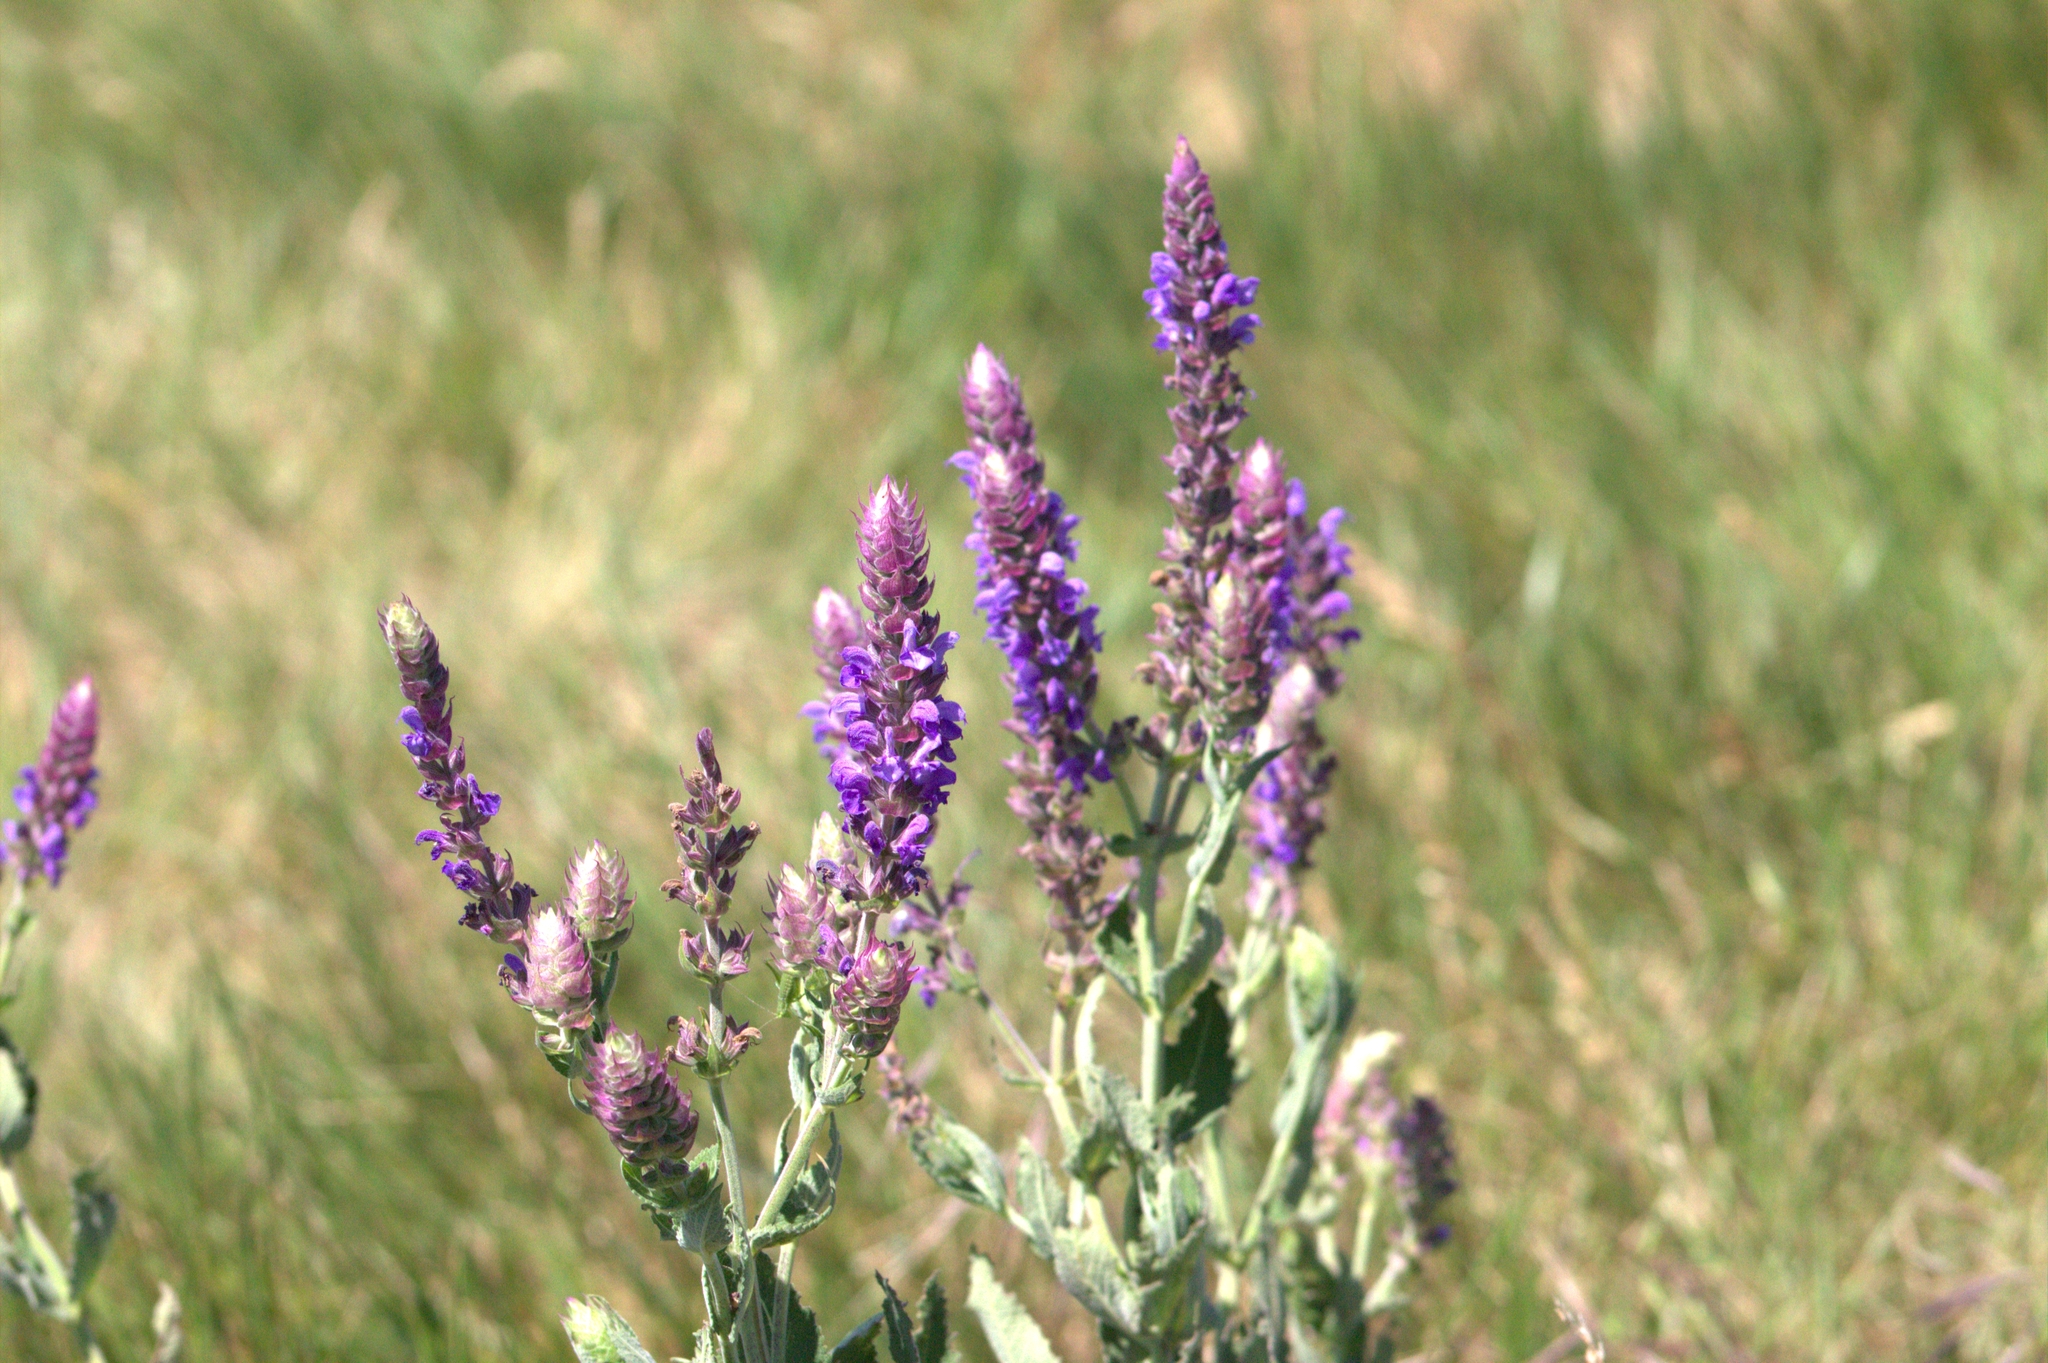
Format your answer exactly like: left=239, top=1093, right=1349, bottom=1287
left=829, top=479, right=963, bottom=903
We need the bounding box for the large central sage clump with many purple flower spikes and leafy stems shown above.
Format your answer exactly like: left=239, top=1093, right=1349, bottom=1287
left=380, top=141, right=1456, bottom=1363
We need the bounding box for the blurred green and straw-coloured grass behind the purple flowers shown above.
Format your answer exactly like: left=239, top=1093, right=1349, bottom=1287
left=0, top=0, right=2048, bottom=1363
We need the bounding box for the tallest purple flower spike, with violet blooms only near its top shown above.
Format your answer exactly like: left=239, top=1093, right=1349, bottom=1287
left=1141, top=137, right=1260, bottom=712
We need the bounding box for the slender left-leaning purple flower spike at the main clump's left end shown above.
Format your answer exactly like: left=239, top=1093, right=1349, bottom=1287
left=377, top=598, right=532, bottom=941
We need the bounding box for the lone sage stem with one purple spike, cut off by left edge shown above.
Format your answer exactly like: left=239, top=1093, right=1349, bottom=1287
left=0, top=677, right=184, bottom=1363
